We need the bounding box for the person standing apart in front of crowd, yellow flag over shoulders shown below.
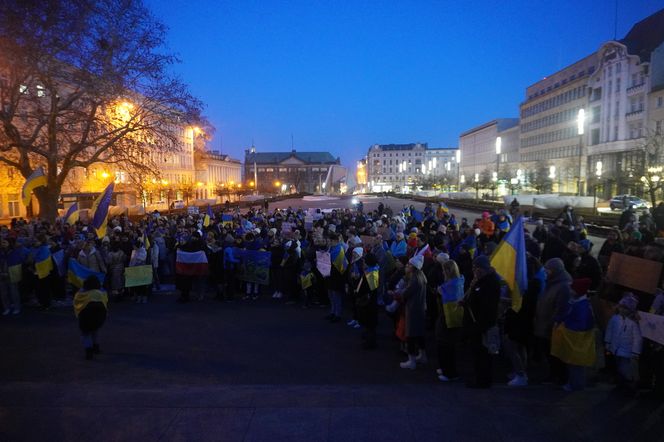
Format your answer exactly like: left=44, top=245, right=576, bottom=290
left=74, top=276, right=108, bottom=360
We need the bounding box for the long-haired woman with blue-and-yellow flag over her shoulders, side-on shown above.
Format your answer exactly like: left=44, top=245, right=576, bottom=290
left=436, top=260, right=465, bottom=382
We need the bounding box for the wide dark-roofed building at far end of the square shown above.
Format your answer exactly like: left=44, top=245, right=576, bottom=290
left=244, top=148, right=343, bottom=193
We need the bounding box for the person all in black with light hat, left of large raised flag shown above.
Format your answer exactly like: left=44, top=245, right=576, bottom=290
left=461, top=255, right=500, bottom=388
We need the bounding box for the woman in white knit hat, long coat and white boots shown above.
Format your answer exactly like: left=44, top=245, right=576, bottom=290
left=400, top=255, right=427, bottom=370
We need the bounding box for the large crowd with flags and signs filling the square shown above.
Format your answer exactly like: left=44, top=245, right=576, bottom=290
left=0, top=202, right=664, bottom=396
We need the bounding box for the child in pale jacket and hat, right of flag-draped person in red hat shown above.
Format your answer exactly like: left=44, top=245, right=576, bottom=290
left=604, top=292, right=643, bottom=388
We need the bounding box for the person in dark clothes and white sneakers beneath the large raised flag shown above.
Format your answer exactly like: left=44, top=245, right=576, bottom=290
left=503, top=255, right=546, bottom=387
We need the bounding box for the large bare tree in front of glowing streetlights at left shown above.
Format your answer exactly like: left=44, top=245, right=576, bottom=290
left=0, top=0, right=202, bottom=219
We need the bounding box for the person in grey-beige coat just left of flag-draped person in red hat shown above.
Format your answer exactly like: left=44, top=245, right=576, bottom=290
left=534, top=258, right=572, bottom=385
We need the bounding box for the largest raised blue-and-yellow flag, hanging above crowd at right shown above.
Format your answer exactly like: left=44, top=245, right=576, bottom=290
left=491, top=216, right=528, bottom=312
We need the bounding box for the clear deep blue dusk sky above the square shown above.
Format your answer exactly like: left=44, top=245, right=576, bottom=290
left=147, top=0, right=664, bottom=166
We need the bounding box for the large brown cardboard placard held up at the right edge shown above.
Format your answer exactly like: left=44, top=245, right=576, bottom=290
left=606, top=252, right=662, bottom=293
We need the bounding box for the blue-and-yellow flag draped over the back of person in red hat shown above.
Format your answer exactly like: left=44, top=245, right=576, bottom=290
left=551, top=296, right=596, bottom=367
